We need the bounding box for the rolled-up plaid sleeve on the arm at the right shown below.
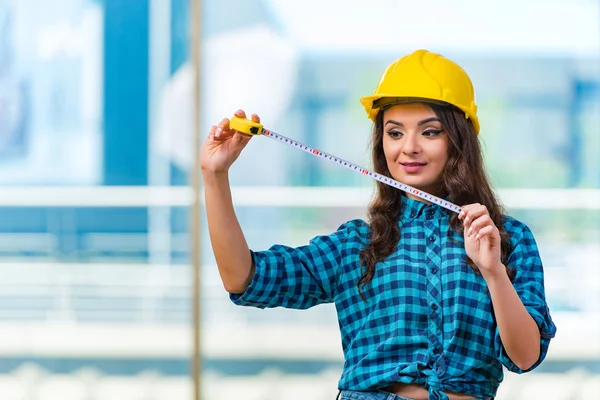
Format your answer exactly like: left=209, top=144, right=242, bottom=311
left=495, top=221, right=556, bottom=374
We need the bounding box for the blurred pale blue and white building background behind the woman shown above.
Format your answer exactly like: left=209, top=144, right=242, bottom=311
left=0, top=0, right=600, bottom=400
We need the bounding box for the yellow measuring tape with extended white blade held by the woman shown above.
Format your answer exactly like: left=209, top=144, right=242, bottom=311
left=229, top=116, right=460, bottom=213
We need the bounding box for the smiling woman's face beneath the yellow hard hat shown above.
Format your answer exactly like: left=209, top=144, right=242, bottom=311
left=383, top=104, right=448, bottom=198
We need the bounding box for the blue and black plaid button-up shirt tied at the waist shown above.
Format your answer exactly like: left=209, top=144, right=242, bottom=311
left=230, top=197, right=556, bottom=399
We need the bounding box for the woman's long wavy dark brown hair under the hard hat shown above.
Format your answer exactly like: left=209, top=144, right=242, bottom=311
left=358, top=103, right=514, bottom=299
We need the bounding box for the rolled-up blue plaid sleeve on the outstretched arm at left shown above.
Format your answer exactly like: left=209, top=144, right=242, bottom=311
left=229, top=221, right=353, bottom=309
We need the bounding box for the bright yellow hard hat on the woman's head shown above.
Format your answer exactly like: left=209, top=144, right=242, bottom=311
left=360, top=50, right=479, bottom=134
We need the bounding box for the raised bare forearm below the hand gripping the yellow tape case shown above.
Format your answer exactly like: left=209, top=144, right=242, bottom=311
left=203, top=172, right=254, bottom=293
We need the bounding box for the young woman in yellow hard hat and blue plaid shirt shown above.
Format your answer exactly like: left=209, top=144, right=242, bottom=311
left=201, top=50, right=556, bottom=400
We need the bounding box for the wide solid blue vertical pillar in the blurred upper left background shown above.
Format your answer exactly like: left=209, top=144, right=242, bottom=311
left=103, top=0, right=149, bottom=185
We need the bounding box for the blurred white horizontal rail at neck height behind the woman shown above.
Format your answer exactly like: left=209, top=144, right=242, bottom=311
left=0, top=186, right=600, bottom=210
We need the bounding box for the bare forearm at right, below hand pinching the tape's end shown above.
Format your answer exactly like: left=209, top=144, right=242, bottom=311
left=484, top=269, right=540, bottom=370
